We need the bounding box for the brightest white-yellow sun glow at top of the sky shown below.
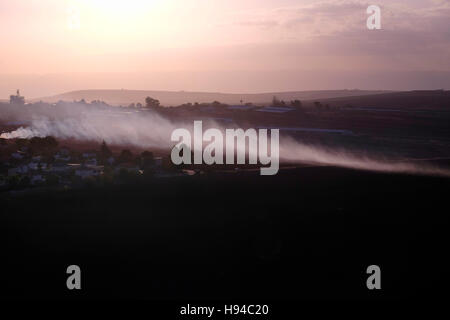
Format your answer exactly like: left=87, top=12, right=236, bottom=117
left=68, top=0, right=172, bottom=49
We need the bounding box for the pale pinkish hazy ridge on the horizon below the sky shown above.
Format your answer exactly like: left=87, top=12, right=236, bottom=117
left=31, top=90, right=389, bottom=106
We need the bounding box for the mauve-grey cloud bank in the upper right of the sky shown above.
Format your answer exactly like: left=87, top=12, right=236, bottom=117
left=229, top=0, right=450, bottom=70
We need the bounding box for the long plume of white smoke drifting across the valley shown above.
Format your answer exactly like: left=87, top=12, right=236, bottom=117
left=0, top=103, right=450, bottom=176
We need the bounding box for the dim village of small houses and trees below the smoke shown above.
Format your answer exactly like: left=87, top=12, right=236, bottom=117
left=0, top=137, right=188, bottom=192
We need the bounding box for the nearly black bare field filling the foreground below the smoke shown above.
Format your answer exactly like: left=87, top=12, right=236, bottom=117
left=0, top=167, right=450, bottom=302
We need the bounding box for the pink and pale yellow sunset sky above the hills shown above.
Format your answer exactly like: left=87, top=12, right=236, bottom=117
left=0, top=0, right=450, bottom=98
